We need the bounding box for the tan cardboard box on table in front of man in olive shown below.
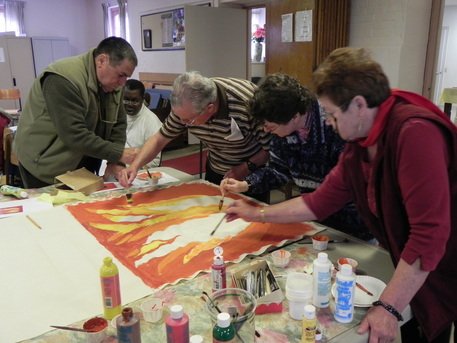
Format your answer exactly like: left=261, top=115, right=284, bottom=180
left=56, top=168, right=103, bottom=195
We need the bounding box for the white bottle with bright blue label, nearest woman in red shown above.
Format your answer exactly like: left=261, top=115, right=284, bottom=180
left=333, top=264, right=355, bottom=323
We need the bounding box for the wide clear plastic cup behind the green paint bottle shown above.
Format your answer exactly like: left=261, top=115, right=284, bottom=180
left=206, top=288, right=257, bottom=342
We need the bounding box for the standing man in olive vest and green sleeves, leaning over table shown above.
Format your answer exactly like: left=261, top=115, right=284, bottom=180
left=14, top=37, right=138, bottom=188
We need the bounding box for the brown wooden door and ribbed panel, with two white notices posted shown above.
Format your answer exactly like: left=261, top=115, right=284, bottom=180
left=266, top=0, right=349, bottom=87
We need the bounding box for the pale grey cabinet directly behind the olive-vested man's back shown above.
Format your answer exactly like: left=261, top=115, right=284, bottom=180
left=32, top=37, right=70, bottom=76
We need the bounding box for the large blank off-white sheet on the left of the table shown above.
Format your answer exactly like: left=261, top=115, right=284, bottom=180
left=0, top=207, right=153, bottom=342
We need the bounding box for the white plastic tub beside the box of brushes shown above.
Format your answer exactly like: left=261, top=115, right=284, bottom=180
left=286, top=272, right=313, bottom=320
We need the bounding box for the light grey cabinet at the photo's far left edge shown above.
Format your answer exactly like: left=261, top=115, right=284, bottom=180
left=0, top=36, right=35, bottom=108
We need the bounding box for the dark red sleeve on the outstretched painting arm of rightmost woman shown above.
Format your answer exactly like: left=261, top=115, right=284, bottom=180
left=302, top=156, right=352, bottom=220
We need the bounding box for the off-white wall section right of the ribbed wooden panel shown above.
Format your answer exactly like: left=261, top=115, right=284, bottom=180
left=349, top=0, right=432, bottom=93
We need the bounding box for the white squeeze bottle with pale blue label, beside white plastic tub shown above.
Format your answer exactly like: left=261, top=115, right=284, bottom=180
left=313, top=252, right=331, bottom=308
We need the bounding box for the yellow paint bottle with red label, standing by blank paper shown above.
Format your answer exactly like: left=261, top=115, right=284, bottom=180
left=100, top=257, right=122, bottom=320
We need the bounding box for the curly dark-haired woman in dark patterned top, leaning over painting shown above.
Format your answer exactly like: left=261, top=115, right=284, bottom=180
left=221, top=74, right=373, bottom=240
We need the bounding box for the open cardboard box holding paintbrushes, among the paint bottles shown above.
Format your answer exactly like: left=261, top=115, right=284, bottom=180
left=232, top=260, right=284, bottom=314
